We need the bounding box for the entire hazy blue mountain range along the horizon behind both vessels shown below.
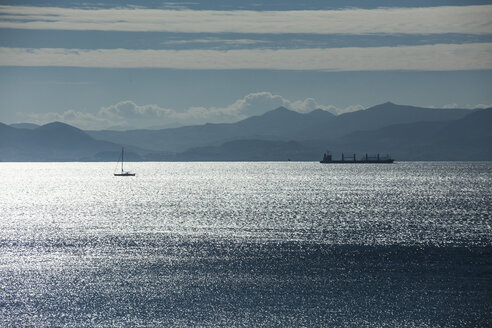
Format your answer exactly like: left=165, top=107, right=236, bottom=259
left=0, top=103, right=492, bottom=161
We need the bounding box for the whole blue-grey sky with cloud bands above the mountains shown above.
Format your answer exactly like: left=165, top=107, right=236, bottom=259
left=0, top=0, right=492, bottom=130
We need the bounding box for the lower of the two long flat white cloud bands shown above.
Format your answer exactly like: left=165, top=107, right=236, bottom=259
left=0, top=43, right=492, bottom=71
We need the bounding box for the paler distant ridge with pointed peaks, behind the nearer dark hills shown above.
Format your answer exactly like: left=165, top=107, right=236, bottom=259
left=88, top=103, right=471, bottom=152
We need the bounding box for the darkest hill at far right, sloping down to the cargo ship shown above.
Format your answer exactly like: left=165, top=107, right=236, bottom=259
left=331, top=109, right=492, bottom=160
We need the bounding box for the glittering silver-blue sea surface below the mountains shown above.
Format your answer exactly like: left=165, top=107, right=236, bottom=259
left=0, top=162, right=492, bottom=327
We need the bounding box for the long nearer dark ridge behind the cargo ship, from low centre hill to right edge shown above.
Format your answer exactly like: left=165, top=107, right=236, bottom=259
left=159, top=108, right=492, bottom=161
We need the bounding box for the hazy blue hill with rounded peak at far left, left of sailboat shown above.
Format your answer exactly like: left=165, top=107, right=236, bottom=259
left=0, top=122, right=143, bottom=161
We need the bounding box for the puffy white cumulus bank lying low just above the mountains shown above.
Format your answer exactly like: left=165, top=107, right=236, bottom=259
left=24, top=92, right=365, bottom=130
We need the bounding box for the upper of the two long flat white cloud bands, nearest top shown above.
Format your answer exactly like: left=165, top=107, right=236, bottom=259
left=0, top=5, right=492, bottom=34
